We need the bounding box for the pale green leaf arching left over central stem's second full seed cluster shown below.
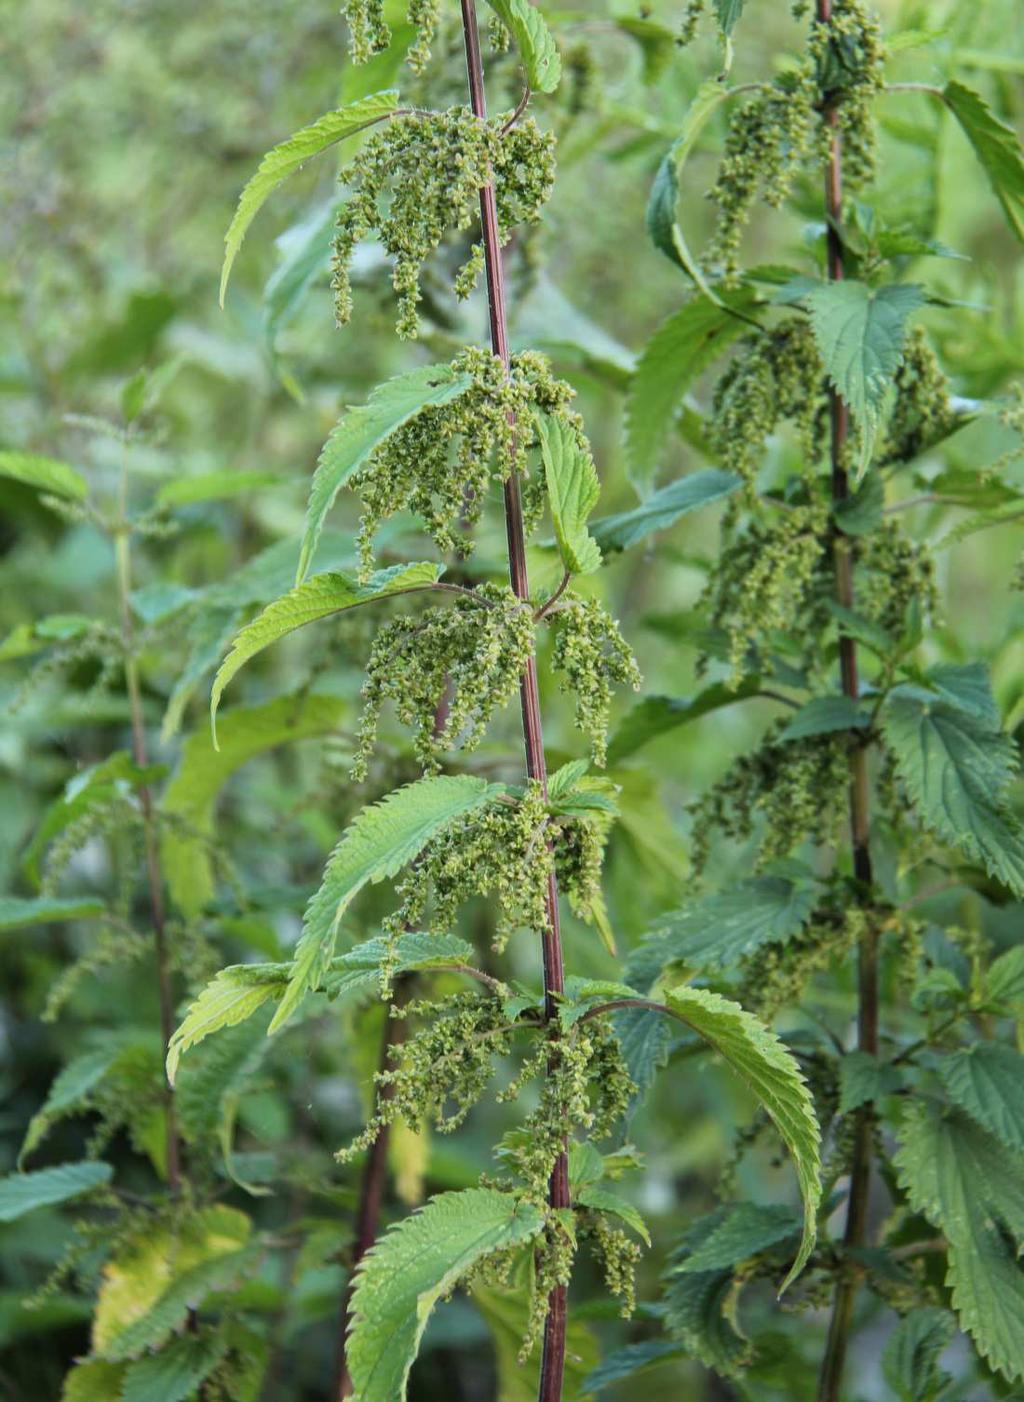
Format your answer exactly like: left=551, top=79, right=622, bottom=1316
left=295, top=365, right=473, bottom=585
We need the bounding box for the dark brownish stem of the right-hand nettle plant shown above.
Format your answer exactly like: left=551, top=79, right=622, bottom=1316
left=818, top=0, right=878, bottom=1402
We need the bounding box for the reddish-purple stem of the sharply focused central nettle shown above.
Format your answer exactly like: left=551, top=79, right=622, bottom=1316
left=462, top=0, right=571, bottom=1402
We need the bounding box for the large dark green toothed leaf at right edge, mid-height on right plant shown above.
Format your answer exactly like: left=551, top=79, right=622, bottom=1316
left=882, top=694, right=1024, bottom=896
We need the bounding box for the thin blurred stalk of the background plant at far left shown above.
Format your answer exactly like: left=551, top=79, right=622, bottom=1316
left=115, top=496, right=181, bottom=1197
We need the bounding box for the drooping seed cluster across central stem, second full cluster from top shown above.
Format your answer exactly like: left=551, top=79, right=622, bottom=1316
left=351, top=346, right=582, bottom=575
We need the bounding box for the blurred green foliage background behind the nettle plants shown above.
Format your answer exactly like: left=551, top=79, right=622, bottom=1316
left=0, top=0, right=1024, bottom=1402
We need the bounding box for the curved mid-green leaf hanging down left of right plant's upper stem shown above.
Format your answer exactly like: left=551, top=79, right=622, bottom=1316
left=617, top=289, right=756, bottom=499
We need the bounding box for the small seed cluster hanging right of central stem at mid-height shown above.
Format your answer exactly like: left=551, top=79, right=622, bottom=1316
left=548, top=593, right=641, bottom=764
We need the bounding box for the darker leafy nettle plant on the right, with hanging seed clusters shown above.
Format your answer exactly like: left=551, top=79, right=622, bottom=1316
left=597, top=0, right=1024, bottom=1402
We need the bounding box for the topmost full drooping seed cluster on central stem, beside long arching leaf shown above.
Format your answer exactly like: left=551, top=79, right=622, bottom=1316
left=332, top=107, right=554, bottom=336
